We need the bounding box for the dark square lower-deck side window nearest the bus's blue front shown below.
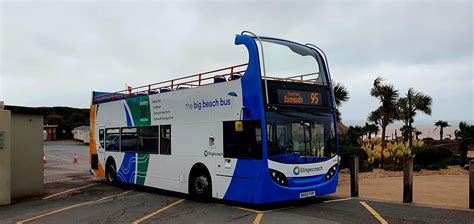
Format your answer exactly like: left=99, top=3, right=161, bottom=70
left=223, top=120, right=263, bottom=159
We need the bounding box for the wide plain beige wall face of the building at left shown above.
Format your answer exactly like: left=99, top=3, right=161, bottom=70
left=11, top=112, right=44, bottom=199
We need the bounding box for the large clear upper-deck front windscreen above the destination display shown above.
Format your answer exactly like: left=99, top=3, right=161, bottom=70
left=257, top=38, right=327, bottom=85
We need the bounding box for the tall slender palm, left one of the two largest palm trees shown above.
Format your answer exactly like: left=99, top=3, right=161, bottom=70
left=370, top=77, right=398, bottom=168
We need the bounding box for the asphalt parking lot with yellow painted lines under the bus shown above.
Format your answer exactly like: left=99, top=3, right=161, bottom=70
left=0, top=142, right=474, bottom=223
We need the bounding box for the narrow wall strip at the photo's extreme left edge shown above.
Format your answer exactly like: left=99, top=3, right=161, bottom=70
left=0, top=109, right=11, bottom=205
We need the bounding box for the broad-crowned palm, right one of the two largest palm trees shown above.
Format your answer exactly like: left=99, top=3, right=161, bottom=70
left=397, top=88, right=433, bottom=147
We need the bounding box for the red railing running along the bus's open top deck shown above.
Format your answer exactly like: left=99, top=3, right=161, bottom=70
left=92, top=64, right=319, bottom=104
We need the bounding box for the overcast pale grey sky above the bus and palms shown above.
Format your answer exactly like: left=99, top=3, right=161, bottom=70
left=0, top=1, right=474, bottom=130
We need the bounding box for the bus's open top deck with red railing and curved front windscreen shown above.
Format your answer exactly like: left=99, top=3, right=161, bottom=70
left=92, top=34, right=330, bottom=107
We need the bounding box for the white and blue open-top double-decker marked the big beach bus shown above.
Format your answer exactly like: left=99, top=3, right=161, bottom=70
left=90, top=31, right=338, bottom=204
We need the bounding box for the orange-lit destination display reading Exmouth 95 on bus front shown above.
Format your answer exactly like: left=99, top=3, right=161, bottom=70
left=277, top=89, right=322, bottom=106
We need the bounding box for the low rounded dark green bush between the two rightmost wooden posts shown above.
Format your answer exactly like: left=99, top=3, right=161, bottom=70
left=413, top=146, right=453, bottom=169
